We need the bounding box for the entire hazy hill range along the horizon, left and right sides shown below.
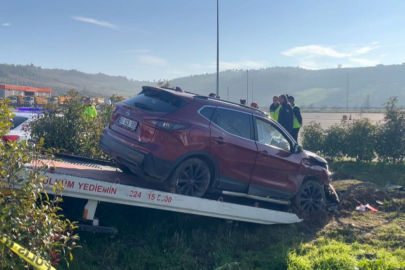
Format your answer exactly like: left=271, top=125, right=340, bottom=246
left=0, top=64, right=405, bottom=107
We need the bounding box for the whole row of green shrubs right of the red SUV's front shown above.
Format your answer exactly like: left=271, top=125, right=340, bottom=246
left=302, top=97, right=405, bottom=163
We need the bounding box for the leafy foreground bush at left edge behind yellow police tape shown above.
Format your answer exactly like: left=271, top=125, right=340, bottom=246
left=0, top=102, right=78, bottom=269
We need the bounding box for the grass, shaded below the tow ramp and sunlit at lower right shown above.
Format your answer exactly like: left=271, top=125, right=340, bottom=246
left=59, top=162, right=405, bottom=270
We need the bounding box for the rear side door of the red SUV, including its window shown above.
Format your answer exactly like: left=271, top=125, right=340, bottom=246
left=210, top=107, right=257, bottom=192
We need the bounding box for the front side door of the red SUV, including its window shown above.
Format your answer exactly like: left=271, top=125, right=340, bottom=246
left=249, top=117, right=302, bottom=199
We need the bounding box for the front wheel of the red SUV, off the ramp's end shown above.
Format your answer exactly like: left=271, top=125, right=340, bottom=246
left=293, top=180, right=326, bottom=213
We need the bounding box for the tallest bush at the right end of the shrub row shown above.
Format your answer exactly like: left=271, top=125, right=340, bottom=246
left=376, top=97, right=405, bottom=163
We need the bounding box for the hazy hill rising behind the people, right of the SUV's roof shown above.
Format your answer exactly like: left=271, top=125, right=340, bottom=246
left=171, top=65, right=405, bottom=107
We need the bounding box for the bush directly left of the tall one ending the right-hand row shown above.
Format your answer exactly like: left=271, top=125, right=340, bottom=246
left=345, top=118, right=377, bottom=161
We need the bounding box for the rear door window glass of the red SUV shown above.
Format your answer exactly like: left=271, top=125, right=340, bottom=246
left=212, top=108, right=251, bottom=139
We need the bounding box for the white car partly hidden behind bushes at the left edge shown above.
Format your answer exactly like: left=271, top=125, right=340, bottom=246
left=2, top=112, right=41, bottom=142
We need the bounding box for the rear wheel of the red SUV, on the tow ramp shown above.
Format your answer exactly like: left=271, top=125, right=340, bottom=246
left=165, top=158, right=211, bottom=197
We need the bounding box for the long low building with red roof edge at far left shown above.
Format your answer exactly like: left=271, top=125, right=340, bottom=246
left=0, top=84, right=53, bottom=98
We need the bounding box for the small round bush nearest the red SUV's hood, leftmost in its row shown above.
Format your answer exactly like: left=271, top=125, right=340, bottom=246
left=302, top=122, right=325, bottom=153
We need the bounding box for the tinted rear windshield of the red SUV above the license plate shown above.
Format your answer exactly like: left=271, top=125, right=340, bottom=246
left=124, top=90, right=187, bottom=113
